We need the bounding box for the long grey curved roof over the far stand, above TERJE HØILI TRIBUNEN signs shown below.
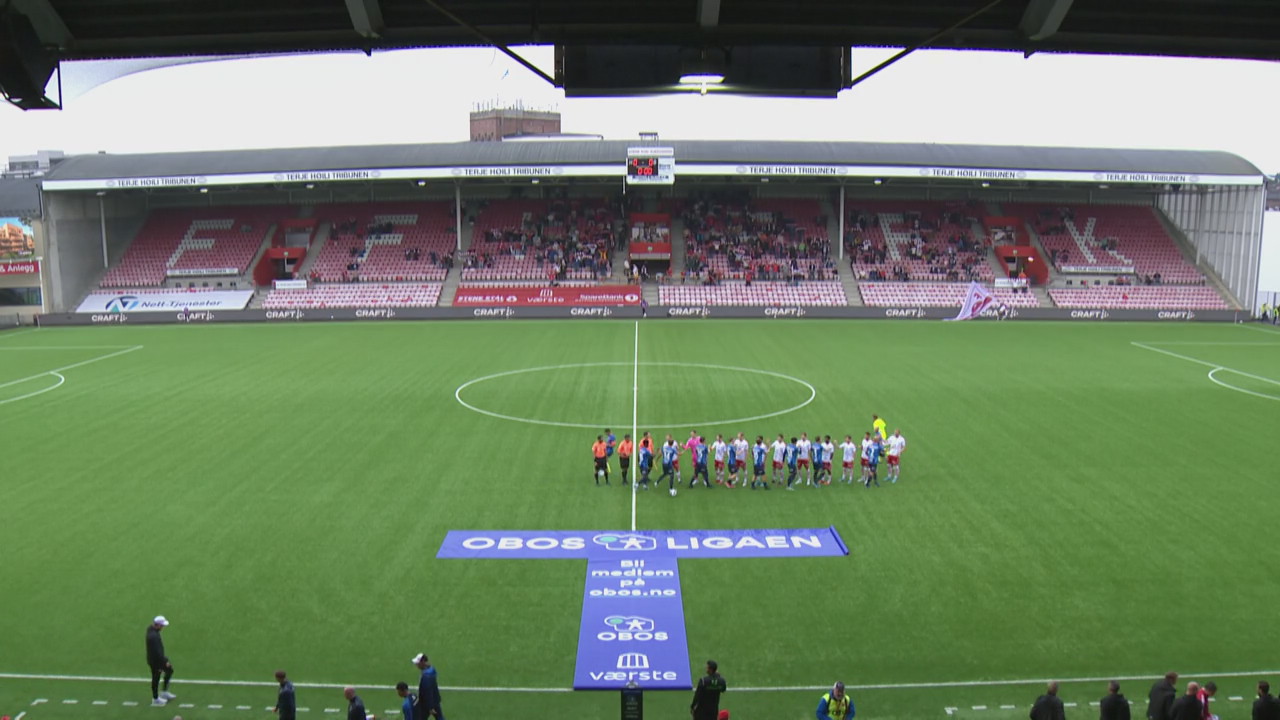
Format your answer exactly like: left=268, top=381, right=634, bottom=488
left=45, top=140, right=1262, bottom=181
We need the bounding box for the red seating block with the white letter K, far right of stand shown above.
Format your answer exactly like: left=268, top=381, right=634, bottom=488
left=1005, top=204, right=1204, bottom=284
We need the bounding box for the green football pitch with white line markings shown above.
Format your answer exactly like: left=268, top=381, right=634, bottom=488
left=0, top=320, right=1280, bottom=720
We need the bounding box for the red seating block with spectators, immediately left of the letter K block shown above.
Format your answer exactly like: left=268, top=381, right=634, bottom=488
left=845, top=200, right=995, bottom=283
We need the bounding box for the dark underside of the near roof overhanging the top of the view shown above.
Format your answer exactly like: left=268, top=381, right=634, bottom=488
left=14, top=0, right=1280, bottom=59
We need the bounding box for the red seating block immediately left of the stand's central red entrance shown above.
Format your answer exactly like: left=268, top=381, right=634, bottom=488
left=462, top=199, right=614, bottom=283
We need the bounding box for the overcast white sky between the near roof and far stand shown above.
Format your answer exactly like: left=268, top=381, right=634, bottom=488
left=0, top=47, right=1280, bottom=173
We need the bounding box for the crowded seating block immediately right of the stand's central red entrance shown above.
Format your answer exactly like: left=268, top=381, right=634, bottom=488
left=664, top=192, right=836, bottom=281
